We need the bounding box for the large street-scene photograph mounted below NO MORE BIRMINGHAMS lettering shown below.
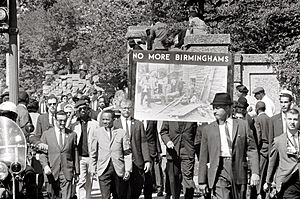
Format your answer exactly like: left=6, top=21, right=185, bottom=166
left=134, top=63, right=228, bottom=122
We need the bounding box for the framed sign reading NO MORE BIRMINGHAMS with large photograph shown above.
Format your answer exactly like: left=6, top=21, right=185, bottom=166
left=130, top=51, right=232, bottom=122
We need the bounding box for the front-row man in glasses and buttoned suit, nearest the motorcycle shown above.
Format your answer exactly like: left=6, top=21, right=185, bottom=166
left=40, top=111, right=79, bottom=199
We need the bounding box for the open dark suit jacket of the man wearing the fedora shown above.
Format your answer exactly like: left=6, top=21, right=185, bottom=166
left=198, top=119, right=259, bottom=188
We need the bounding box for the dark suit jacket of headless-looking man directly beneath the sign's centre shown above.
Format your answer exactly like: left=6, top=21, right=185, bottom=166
left=160, top=121, right=197, bottom=159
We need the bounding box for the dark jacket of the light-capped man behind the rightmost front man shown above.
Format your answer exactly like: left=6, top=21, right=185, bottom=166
left=269, top=113, right=283, bottom=151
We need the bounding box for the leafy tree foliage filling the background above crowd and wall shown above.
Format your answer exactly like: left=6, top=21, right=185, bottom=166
left=0, top=0, right=300, bottom=95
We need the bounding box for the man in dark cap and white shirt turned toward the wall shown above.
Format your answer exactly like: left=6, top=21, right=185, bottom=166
left=252, top=87, right=275, bottom=117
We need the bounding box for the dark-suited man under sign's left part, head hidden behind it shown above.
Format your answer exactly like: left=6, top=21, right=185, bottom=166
left=144, top=120, right=163, bottom=199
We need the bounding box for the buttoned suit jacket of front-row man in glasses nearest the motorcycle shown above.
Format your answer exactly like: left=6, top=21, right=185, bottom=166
left=40, top=128, right=79, bottom=181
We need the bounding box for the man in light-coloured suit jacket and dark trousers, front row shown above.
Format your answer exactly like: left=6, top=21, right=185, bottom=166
left=91, top=110, right=132, bottom=199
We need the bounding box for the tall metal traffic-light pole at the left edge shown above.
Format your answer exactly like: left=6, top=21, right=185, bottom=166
left=8, top=0, right=19, bottom=104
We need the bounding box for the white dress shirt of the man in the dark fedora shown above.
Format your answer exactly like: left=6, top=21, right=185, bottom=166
left=219, top=118, right=233, bottom=157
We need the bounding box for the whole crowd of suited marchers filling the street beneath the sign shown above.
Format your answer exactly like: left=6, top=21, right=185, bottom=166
left=0, top=81, right=300, bottom=199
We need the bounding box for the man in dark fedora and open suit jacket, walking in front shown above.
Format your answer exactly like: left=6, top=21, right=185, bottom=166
left=198, top=93, right=259, bottom=199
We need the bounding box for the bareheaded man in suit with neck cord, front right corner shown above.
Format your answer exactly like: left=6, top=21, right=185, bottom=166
left=264, top=109, right=300, bottom=199
